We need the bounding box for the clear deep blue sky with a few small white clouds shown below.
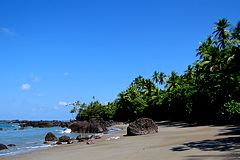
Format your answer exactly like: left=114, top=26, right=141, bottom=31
left=0, top=0, right=240, bottom=120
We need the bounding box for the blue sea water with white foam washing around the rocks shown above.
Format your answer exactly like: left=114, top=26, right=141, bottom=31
left=0, top=123, right=79, bottom=157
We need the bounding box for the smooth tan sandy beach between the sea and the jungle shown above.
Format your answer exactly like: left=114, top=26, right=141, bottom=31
left=0, top=123, right=240, bottom=160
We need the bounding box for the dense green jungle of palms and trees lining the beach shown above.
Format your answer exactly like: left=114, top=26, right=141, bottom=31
left=71, top=19, right=240, bottom=123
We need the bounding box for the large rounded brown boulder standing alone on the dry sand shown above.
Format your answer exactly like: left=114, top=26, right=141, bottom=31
left=127, top=118, right=158, bottom=136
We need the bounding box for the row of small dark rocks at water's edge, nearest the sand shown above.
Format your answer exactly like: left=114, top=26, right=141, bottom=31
left=44, top=132, right=101, bottom=145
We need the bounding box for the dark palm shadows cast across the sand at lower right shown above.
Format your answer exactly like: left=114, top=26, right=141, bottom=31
left=171, top=126, right=240, bottom=160
